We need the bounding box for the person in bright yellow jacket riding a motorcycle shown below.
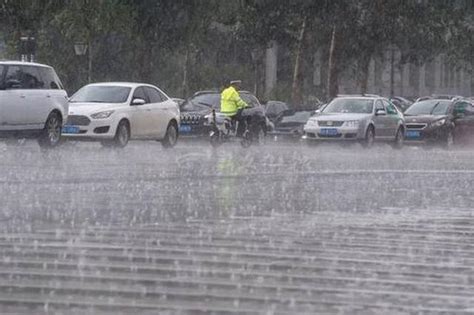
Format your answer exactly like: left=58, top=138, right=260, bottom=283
left=221, top=80, right=248, bottom=134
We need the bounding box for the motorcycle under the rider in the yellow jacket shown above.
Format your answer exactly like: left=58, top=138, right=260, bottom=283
left=209, top=109, right=266, bottom=148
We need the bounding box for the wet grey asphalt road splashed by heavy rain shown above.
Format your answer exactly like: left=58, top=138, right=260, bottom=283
left=0, top=142, right=474, bottom=314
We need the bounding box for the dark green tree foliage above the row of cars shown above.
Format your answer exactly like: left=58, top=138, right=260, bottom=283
left=0, top=0, right=474, bottom=99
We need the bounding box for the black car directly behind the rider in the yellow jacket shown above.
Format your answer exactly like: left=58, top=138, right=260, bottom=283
left=179, top=91, right=273, bottom=136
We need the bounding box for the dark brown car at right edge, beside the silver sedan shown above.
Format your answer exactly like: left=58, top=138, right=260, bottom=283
left=405, top=99, right=474, bottom=147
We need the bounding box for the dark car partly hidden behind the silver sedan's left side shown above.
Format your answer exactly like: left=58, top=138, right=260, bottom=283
left=269, top=109, right=315, bottom=141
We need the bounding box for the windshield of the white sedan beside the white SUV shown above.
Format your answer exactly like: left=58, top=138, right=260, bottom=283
left=70, top=85, right=132, bottom=103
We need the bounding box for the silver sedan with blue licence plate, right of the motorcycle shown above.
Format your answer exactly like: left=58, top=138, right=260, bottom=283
left=303, top=96, right=405, bottom=147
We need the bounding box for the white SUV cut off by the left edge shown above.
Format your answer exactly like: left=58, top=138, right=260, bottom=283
left=0, top=61, right=69, bottom=147
